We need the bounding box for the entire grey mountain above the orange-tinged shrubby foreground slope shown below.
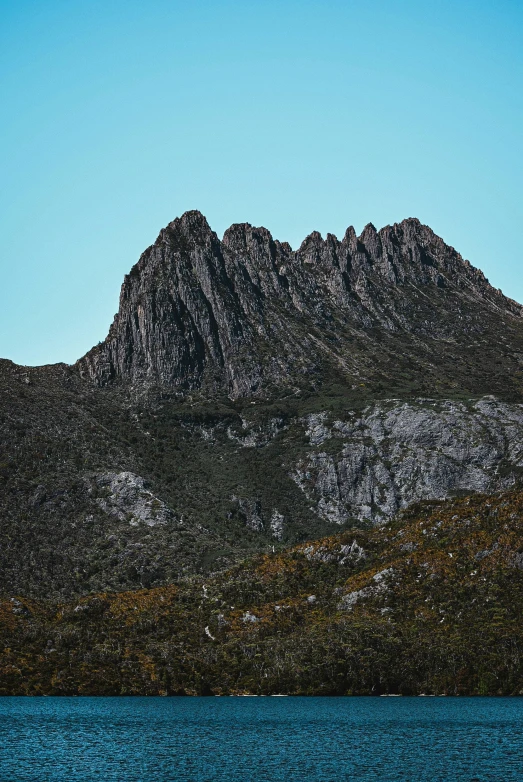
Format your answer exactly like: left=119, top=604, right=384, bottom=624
left=0, top=212, right=523, bottom=600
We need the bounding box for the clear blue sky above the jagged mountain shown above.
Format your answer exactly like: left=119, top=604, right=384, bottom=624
left=0, top=0, right=523, bottom=364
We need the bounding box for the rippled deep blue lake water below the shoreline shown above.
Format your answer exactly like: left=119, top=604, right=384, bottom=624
left=0, top=698, right=523, bottom=782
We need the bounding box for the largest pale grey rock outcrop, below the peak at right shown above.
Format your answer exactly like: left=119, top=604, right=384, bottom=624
left=292, top=398, right=523, bottom=524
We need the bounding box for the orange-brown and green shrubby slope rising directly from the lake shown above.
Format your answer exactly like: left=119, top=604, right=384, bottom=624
left=4, top=492, right=523, bottom=694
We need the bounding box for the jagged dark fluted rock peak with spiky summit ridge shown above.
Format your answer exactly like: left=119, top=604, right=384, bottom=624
left=77, top=212, right=522, bottom=398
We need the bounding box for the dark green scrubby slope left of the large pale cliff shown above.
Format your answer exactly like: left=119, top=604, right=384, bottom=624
left=0, top=362, right=352, bottom=596
